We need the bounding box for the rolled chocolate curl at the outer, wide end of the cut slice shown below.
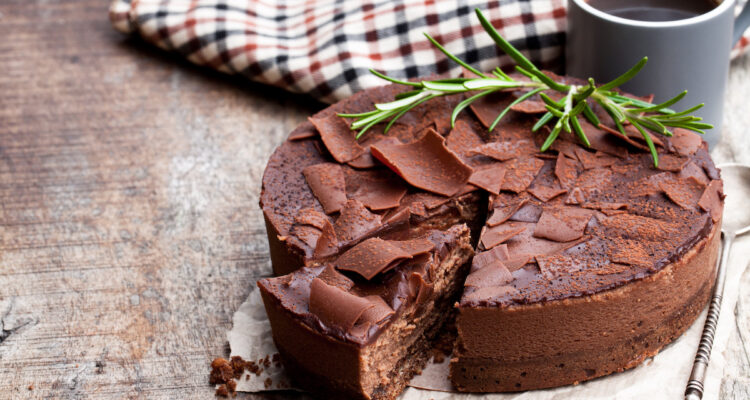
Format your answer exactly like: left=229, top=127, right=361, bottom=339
left=310, top=278, right=375, bottom=331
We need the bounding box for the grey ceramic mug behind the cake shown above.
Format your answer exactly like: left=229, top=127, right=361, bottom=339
left=566, top=0, right=750, bottom=146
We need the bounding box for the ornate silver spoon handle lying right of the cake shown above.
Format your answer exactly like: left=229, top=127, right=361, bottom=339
left=685, top=234, right=734, bottom=400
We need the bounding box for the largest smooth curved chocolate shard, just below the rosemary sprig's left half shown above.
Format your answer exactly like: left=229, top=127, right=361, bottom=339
left=371, top=129, right=473, bottom=196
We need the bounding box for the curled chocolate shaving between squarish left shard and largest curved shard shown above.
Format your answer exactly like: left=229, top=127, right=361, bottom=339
left=346, top=169, right=406, bottom=211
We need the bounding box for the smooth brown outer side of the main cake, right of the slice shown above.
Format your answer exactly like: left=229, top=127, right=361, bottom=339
left=451, top=220, right=720, bottom=392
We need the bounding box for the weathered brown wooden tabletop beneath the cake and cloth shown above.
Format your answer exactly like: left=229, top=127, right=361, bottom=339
left=0, top=0, right=750, bottom=399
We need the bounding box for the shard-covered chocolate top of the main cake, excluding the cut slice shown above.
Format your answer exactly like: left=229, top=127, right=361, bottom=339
left=261, top=72, right=723, bottom=306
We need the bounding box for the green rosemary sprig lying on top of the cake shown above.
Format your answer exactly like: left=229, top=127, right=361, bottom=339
left=339, top=8, right=713, bottom=167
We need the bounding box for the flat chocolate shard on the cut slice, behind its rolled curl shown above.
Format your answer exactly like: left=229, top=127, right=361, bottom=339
left=334, top=238, right=411, bottom=280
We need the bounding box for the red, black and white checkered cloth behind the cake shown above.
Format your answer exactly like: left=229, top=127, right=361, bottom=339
left=110, top=0, right=750, bottom=102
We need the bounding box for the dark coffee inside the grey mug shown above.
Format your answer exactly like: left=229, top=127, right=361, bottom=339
left=587, top=0, right=717, bottom=22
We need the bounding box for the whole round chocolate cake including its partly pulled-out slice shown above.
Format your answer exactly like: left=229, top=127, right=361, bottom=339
left=258, top=76, right=723, bottom=399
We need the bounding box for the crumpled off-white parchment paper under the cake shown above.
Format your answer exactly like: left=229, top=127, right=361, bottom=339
left=227, top=237, right=750, bottom=400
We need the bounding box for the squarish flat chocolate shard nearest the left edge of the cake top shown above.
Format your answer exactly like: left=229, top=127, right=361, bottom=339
left=302, top=163, right=346, bottom=214
